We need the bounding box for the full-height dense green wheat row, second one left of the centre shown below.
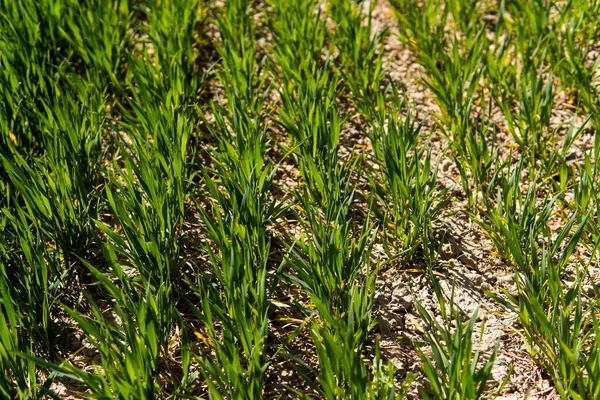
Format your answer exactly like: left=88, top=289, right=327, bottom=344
left=52, top=2, right=203, bottom=398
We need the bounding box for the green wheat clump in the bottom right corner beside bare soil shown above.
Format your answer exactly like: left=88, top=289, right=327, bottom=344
left=498, top=216, right=600, bottom=399
